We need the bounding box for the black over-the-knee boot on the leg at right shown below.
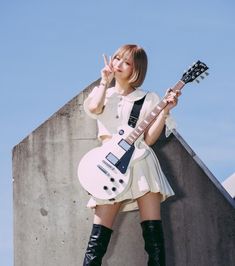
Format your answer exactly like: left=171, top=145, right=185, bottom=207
left=141, top=220, right=165, bottom=266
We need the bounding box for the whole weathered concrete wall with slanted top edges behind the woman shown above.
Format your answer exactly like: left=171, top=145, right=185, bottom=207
left=13, top=80, right=235, bottom=266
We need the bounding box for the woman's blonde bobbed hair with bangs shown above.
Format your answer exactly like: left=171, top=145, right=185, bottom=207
left=112, top=44, right=148, bottom=88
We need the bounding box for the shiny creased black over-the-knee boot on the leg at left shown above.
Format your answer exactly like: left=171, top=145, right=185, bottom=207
left=83, top=224, right=113, bottom=266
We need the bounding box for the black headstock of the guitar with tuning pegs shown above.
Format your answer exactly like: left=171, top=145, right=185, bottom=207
left=181, top=60, right=208, bottom=84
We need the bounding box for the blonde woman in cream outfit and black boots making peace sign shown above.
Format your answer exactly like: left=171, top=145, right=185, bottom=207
left=83, top=45, right=180, bottom=265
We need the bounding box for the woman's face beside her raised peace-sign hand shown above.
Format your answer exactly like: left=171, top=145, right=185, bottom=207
left=112, top=53, right=133, bottom=81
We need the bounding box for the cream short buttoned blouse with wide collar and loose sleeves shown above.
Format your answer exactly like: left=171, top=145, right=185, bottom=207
left=84, top=87, right=176, bottom=139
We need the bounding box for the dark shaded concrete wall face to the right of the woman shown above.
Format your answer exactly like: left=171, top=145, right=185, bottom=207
left=154, top=132, right=235, bottom=266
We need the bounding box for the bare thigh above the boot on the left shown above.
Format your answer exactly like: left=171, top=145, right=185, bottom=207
left=94, top=203, right=121, bottom=228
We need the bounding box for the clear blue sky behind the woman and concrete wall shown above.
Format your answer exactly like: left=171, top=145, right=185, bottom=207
left=0, top=0, right=235, bottom=266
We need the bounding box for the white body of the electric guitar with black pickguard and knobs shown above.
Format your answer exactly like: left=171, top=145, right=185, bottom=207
left=78, top=126, right=148, bottom=200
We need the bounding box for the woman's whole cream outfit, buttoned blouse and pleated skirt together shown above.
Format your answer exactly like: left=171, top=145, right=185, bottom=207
left=81, top=87, right=175, bottom=211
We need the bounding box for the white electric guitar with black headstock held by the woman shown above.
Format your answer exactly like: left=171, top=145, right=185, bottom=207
left=78, top=61, right=208, bottom=200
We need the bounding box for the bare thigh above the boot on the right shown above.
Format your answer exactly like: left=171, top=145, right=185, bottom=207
left=137, top=192, right=162, bottom=221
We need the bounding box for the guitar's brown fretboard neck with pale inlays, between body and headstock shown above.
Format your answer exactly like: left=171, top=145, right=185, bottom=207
left=125, top=80, right=185, bottom=145
